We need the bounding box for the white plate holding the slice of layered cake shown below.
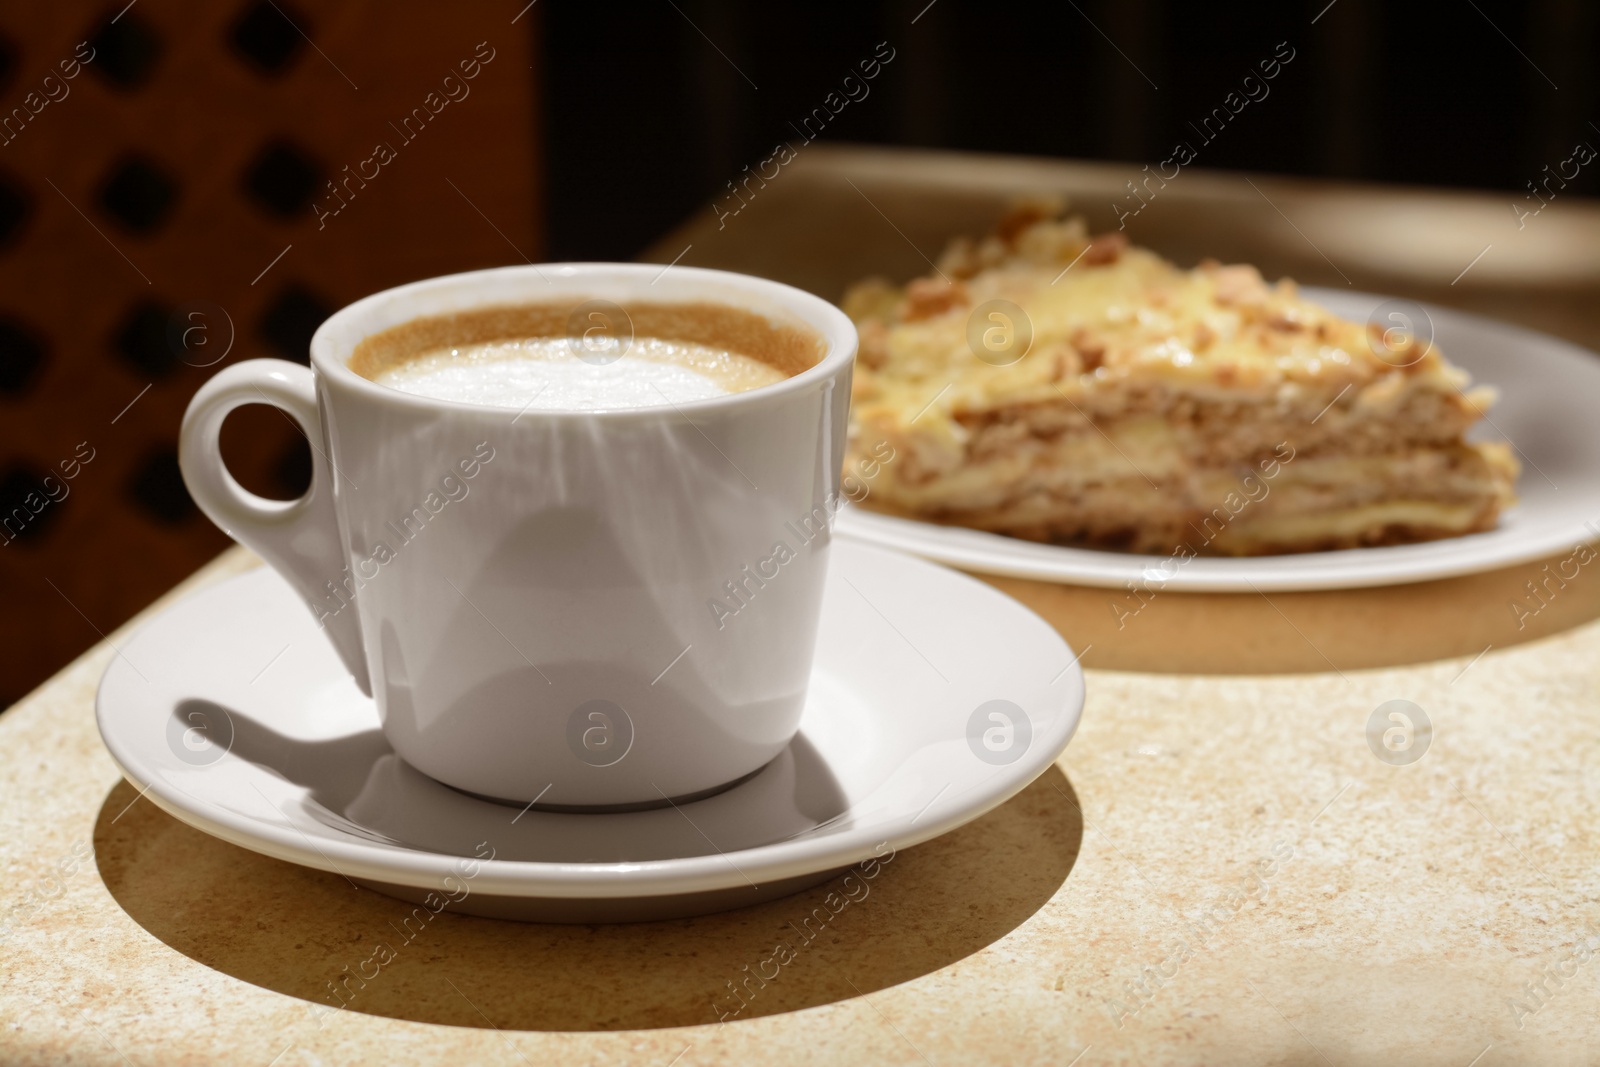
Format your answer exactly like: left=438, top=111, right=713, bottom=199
left=837, top=290, right=1600, bottom=592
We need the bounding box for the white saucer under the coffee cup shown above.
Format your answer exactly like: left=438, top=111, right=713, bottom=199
left=98, top=542, right=1083, bottom=921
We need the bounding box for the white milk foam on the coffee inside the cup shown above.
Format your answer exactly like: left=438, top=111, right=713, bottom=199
left=374, top=338, right=786, bottom=411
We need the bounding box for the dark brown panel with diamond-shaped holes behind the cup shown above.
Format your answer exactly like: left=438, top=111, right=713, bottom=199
left=0, top=0, right=542, bottom=707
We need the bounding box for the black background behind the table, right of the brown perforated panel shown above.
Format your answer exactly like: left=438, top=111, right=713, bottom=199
left=539, top=0, right=1600, bottom=259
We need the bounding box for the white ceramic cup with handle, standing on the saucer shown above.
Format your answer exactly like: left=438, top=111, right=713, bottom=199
left=179, top=264, right=856, bottom=808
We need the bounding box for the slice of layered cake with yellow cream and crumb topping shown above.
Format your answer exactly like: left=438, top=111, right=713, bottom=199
left=843, top=205, right=1518, bottom=555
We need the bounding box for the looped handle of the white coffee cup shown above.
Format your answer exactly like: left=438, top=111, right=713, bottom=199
left=178, top=360, right=373, bottom=696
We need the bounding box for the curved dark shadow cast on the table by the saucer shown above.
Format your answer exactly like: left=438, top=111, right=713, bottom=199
left=94, top=766, right=1083, bottom=1030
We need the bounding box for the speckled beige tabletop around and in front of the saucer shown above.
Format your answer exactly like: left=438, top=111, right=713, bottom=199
left=0, top=550, right=1600, bottom=1067
